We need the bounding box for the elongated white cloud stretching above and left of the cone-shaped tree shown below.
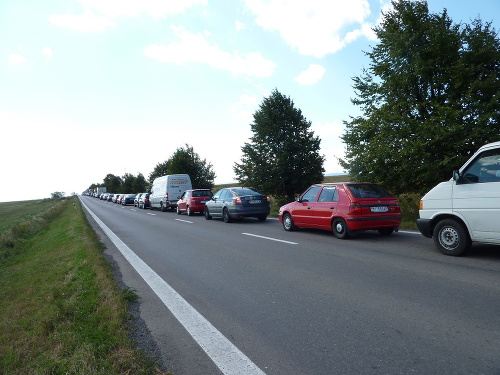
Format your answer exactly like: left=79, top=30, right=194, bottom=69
left=144, top=26, right=276, bottom=77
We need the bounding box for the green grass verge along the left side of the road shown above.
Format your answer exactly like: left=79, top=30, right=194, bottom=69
left=0, top=198, right=168, bottom=374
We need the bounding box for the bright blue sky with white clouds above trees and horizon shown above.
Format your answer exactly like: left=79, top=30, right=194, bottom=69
left=0, top=0, right=500, bottom=202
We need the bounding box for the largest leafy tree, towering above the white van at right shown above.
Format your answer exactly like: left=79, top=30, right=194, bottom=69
left=340, top=0, right=500, bottom=197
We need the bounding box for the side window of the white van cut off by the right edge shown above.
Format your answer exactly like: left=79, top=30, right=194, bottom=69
left=463, top=150, right=500, bottom=184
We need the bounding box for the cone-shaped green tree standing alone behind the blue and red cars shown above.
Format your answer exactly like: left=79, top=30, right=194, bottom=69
left=233, top=89, right=324, bottom=203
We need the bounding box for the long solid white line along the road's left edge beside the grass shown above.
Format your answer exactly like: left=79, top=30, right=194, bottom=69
left=80, top=200, right=265, bottom=375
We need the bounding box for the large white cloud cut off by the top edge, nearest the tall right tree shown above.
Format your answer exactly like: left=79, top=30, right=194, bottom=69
left=244, top=0, right=370, bottom=57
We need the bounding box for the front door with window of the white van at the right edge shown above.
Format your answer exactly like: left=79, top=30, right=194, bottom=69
left=452, top=149, right=500, bottom=243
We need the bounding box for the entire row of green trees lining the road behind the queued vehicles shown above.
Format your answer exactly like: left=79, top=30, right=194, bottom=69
left=91, top=0, right=500, bottom=203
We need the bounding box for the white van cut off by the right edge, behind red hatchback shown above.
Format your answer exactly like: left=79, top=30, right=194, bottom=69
left=417, top=142, right=500, bottom=256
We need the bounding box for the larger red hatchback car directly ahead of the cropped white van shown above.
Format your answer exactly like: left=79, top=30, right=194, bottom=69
left=279, top=182, right=401, bottom=239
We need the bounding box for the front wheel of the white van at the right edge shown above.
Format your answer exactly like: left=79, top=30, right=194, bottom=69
left=432, top=219, right=472, bottom=256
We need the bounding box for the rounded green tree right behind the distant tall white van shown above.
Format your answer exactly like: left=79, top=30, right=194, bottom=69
left=149, top=144, right=215, bottom=189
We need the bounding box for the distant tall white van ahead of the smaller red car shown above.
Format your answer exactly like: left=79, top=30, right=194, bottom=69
left=149, top=174, right=193, bottom=212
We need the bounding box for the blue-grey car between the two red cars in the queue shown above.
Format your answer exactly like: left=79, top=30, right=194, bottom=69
left=203, top=187, right=271, bottom=223
